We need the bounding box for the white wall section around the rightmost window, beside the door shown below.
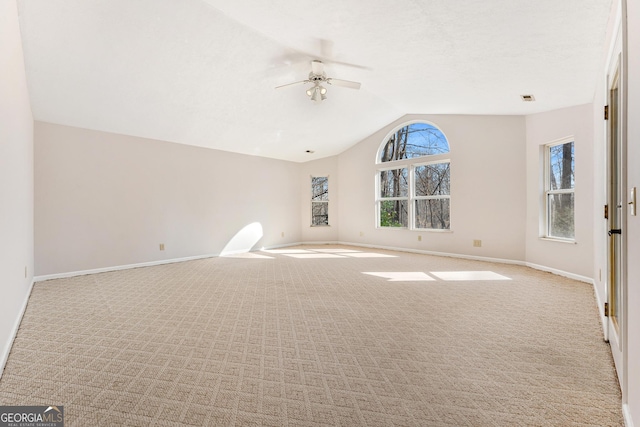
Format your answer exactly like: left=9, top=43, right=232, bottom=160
left=526, top=104, right=594, bottom=279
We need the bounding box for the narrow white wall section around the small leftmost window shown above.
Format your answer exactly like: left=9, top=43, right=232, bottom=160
left=300, top=156, right=340, bottom=242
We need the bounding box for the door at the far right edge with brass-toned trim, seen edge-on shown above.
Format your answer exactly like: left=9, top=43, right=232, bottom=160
left=607, top=49, right=626, bottom=389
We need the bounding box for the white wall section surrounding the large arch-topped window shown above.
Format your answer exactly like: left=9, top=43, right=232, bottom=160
left=338, top=115, right=526, bottom=261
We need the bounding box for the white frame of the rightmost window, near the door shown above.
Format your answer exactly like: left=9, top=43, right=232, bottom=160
left=540, top=136, right=576, bottom=243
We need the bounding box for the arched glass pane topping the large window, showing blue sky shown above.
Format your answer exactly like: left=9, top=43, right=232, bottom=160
left=380, top=123, right=449, bottom=162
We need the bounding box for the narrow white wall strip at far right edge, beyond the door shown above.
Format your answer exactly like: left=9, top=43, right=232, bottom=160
left=627, top=0, right=640, bottom=427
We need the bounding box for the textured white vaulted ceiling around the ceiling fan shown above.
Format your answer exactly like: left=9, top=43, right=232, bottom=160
left=18, top=0, right=611, bottom=161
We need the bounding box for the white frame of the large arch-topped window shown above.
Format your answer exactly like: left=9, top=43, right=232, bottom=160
left=375, top=120, right=452, bottom=232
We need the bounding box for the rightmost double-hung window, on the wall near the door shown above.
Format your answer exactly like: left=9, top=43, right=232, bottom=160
left=544, top=140, right=575, bottom=240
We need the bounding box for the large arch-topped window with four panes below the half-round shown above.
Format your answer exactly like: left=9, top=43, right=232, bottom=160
left=376, top=122, right=451, bottom=230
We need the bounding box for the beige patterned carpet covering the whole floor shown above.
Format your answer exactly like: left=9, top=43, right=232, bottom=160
left=0, top=246, right=624, bottom=427
